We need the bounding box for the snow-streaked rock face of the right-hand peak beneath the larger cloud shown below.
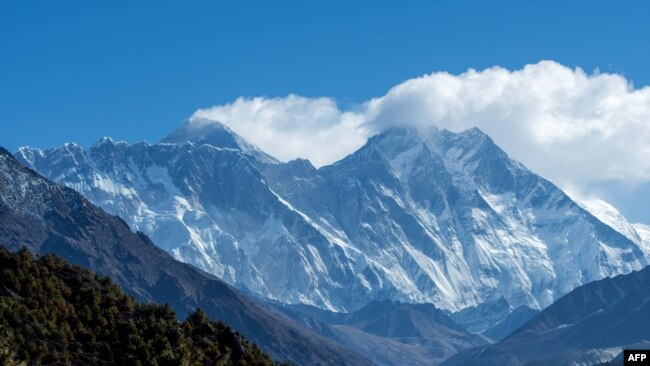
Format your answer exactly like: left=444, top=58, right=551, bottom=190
left=262, top=128, right=647, bottom=312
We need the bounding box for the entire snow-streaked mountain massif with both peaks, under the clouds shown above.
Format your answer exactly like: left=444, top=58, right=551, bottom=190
left=15, top=121, right=650, bottom=320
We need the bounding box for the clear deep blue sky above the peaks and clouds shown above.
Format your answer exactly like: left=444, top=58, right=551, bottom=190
left=0, top=0, right=650, bottom=151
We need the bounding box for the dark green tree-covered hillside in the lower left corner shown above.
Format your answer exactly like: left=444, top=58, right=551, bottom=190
left=0, top=247, right=274, bottom=366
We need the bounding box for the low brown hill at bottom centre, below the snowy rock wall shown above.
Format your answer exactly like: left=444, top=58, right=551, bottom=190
left=283, top=301, right=488, bottom=366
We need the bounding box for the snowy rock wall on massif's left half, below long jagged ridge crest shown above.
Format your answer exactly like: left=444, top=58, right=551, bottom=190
left=19, top=139, right=353, bottom=308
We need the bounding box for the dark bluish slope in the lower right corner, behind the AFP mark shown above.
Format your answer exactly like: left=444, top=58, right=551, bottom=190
left=443, top=267, right=650, bottom=366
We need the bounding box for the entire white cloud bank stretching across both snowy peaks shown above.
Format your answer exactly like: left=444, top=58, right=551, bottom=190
left=193, top=61, right=650, bottom=193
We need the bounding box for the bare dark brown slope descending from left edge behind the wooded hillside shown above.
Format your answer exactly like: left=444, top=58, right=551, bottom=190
left=0, top=148, right=369, bottom=365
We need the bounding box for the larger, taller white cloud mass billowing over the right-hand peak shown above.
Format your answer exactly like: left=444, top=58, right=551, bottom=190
left=366, top=61, right=650, bottom=186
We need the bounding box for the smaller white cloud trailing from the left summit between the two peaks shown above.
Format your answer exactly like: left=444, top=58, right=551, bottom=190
left=191, top=95, right=368, bottom=166
